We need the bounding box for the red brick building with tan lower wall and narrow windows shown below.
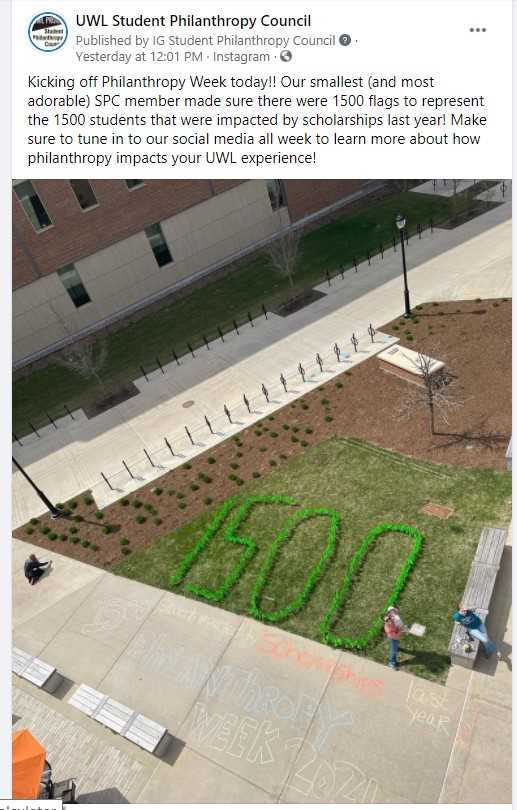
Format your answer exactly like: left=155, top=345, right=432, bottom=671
left=13, top=180, right=364, bottom=366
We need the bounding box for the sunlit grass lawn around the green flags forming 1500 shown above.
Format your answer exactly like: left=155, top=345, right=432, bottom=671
left=115, top=439, right=511, bottom=682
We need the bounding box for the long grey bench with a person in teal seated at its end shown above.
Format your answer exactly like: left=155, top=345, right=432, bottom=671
left=449, top=528, right=507, bottom=669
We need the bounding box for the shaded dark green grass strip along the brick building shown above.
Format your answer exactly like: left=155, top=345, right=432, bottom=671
left=13, top=192, right=450, bottom=436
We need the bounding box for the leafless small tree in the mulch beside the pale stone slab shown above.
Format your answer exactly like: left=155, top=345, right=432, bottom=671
left=398, top=352, right=463, bottom=436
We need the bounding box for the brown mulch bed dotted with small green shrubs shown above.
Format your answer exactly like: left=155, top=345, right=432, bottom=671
left=14, top=299, right=512, bottom=568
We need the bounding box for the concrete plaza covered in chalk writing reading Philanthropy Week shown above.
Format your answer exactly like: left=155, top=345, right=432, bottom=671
left=13, top=540, right=511, bottom=804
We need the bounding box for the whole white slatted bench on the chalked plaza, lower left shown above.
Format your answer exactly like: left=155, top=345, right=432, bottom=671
left=68, top=683, right=168, bottom=756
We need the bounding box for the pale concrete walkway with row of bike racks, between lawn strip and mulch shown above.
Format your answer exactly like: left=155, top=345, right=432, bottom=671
left=13, top=202, right=512, bottom=526
